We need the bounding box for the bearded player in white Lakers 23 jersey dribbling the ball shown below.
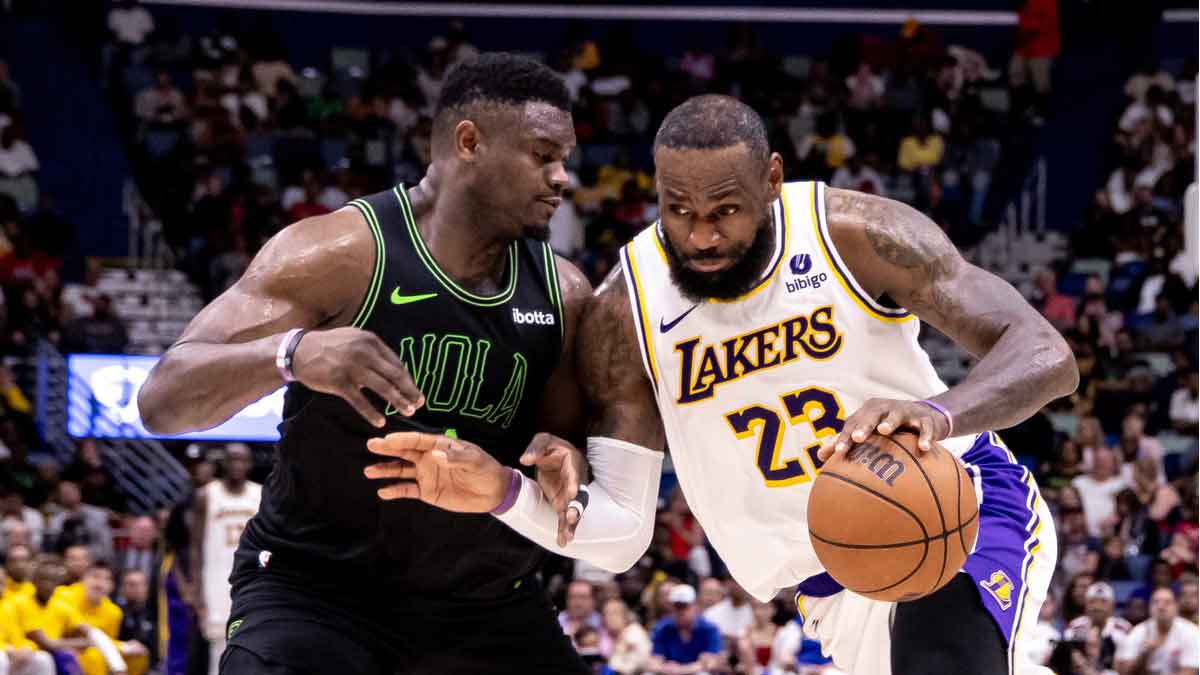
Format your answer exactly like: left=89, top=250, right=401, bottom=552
left=368, top=96, right=1078, bottom=675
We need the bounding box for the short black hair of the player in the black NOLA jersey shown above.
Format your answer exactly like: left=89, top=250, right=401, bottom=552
left=433, top=52, right=571, bottom=144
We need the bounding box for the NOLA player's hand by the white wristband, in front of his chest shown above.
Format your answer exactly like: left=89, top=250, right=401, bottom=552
left=292, top=328, right=425, bottom=428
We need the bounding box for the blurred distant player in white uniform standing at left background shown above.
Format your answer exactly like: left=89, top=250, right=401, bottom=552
left=191, top=443, right=263, bottom=675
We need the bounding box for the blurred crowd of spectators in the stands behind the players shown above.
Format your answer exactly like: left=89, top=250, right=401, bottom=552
left=0, top=0, right=1200, bottom=675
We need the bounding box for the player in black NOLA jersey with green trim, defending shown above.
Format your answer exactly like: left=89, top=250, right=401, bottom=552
left=138, top=54, right=590, bottom=675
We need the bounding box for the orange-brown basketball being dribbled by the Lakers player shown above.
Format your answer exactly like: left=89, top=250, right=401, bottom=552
left=809, top=432, right=979, bottom=602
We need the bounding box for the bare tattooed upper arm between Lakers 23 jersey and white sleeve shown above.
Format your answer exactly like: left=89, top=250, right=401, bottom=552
left=576, top=261, right=666, bottom=449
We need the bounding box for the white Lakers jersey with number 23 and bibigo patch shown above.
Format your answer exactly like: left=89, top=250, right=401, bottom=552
left=622, top=183, right=971, bottom=601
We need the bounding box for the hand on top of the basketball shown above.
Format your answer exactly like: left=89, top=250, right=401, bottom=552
left=817, top=399, right=950, bottom=461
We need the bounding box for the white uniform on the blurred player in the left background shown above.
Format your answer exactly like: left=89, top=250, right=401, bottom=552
left=203, top=480, right=263, bottom=619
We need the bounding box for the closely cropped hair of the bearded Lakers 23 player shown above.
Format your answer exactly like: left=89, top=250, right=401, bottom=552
left=654, top=94, right=770, bottom=165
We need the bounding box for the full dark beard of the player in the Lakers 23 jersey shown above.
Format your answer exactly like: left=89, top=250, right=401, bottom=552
left=662, top=209, right=775, bottom=303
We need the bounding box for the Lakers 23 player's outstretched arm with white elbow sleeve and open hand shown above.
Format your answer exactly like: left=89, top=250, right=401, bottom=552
left=366, top=263, right=665, bottom=572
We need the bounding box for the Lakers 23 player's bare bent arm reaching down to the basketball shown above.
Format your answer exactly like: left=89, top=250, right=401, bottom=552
left=821, top=189, right=1079, bottom=459
